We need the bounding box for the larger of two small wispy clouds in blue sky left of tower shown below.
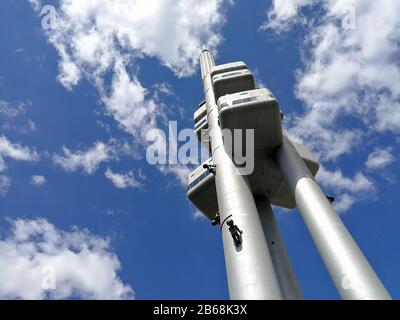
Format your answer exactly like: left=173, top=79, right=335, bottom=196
left=53, top=142, right=114, bottom=174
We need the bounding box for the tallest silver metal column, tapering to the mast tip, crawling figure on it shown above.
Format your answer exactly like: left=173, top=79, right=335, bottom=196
left=200, top=50, right=282, bottom=300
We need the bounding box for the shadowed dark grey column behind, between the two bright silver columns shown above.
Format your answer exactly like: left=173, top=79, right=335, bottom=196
left=255, top=196, right=303, bottom=300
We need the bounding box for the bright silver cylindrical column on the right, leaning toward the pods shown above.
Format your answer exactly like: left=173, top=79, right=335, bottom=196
left=276, top=136, right=390, bottom=300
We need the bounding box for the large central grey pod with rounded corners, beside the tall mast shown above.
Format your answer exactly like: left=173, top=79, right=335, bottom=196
left=218, top=89, right=283, bottom=153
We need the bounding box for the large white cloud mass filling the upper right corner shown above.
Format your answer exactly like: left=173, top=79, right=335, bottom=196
left=269, top=0, right=400, bottom=160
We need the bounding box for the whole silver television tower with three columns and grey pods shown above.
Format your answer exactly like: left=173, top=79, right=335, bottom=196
left=188, top=48, right=390, bottom=300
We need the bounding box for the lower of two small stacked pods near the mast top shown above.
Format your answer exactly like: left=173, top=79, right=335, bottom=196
left=213, top=69, right=256, bottom=101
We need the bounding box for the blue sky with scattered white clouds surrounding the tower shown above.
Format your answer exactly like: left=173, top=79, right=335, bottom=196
left=0, top=0, right=400, bottom=299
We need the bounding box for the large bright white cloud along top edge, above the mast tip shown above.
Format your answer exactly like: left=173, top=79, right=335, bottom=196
left=46, top=0, right=224, bottom=75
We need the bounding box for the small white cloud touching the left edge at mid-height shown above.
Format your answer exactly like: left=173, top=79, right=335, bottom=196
left=0, top=136, right=39, bottom=172
